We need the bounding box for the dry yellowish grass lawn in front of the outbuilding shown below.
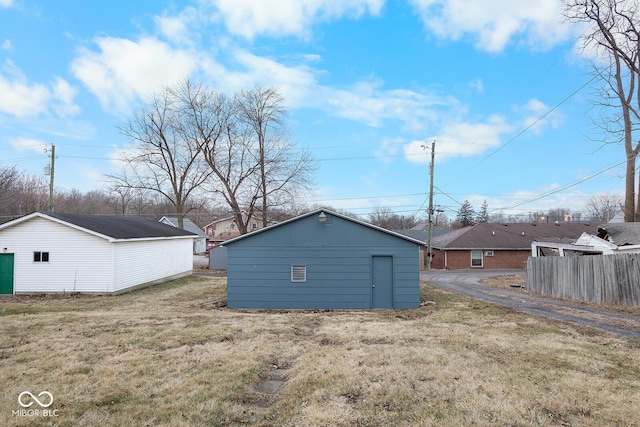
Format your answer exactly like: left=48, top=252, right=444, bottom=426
left=0, top=277, right=640, bottom=426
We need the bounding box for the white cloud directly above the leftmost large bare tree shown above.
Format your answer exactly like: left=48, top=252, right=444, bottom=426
left=71, top=37, right=197, bottom=113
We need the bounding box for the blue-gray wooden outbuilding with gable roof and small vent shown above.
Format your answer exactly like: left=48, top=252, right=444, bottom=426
left=224, top=209, right=424, bottom=309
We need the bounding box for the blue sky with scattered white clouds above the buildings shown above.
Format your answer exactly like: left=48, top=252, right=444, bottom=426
left=0, top=0, right=624, bottom=221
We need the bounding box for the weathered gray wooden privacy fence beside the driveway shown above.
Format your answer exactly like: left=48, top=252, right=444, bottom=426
left=525, top=253, right=640, bottom=305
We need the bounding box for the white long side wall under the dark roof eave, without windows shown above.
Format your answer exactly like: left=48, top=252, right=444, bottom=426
left=113, top=238, right=193, bottom=292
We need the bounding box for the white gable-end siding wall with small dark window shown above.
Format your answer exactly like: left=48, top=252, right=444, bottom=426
left=0, top=218, right=113, bottom=293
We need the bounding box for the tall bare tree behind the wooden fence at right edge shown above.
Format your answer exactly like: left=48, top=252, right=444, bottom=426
left=565, top=0, right=640, bottom=222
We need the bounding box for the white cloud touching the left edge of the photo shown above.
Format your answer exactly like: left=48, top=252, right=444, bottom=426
left=0, top=61, right=78, bottom=119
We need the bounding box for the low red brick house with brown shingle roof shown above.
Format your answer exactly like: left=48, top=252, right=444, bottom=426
left=431, top=222, right=598, bottom=270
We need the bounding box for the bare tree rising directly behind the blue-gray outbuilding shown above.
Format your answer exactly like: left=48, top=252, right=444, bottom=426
left=190, top=88, right=312, bottom=234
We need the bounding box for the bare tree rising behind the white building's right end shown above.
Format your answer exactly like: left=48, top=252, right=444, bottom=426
left=109, top=80, right=211, bottom=228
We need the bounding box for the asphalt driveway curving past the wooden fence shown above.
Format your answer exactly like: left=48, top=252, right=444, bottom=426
left=420, top=270, right=640, bottom=340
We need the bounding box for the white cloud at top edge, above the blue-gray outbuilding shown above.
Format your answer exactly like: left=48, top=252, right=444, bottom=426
left=215, top=0, right=384, bottom=39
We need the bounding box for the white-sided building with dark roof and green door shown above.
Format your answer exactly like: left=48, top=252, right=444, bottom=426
left=0, top=212, right=194, bottom=294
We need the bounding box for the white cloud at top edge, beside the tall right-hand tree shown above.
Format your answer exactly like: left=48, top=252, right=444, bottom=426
left=411, top=0, right=571, bottom=52
